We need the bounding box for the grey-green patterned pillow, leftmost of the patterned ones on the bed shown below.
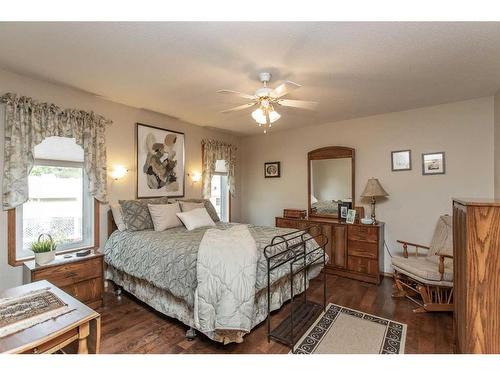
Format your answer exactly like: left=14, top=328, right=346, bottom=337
left=118, top=197, right=168, bottom=231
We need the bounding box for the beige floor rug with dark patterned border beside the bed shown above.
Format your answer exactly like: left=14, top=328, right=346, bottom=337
left=294, top=303, right=406, bottom=354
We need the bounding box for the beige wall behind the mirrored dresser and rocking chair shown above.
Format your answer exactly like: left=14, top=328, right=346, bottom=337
left=241, top=97, right=494, bottom=272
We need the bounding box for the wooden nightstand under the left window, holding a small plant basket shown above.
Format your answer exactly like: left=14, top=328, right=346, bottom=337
left=23, top=251, right=104, bottom=309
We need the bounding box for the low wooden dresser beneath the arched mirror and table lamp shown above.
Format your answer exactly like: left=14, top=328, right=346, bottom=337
left=276, top=217, right=384, bottom=284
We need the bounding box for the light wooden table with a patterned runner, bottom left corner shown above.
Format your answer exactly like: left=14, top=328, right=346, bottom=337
left=0, top=280, right=101, bottom=354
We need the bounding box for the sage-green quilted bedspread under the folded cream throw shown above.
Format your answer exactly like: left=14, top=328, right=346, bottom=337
left=104, top=222, right=324, bottom=308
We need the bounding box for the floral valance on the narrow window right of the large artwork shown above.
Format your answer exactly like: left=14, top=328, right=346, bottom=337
left=201, top=139, right=236, bottom=199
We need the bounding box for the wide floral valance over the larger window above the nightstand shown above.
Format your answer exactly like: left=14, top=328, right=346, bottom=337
left=0, top=93, right=111, bottom=210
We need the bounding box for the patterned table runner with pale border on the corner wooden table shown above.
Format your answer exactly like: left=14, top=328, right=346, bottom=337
left=0, top=288, right=74, bottom=337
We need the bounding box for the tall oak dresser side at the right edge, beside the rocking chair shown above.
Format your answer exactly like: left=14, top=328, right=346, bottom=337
left=453, top=199, right=500, bottom=353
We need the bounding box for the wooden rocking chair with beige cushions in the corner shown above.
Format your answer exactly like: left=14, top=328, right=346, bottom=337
left=392, top=215, right=453, bottom=312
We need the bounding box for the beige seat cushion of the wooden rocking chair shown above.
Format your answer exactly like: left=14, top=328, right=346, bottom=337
left=391, top=256, right=453, bottom=281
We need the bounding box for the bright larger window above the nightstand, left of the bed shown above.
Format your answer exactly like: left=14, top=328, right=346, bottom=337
left=10, top=137, right=96, bottom=260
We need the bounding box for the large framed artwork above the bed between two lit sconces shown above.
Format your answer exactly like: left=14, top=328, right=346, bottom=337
left=136, top=123, right=184, bottom=198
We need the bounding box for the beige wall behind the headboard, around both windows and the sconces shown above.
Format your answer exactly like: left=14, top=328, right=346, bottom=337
left=0, top=70, right=240, bottom=290
